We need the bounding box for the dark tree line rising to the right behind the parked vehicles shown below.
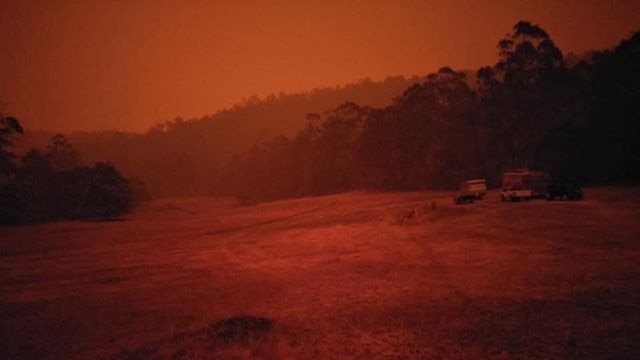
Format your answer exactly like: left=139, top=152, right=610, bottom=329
left=221, top=21, right=640, bottom=199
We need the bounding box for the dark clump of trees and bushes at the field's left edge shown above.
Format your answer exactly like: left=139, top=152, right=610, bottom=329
left=0, top=122, right=134, bottom=225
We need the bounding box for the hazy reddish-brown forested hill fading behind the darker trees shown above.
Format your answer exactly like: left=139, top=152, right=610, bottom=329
left=18, top=76, right=424, bottom=196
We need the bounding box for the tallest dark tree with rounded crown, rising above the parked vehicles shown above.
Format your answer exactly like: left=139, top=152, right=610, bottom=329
left=478, top=21, right=568, bottom=170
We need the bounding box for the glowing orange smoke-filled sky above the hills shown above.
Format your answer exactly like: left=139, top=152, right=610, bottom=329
left=0, top=0, right=640, bottom=131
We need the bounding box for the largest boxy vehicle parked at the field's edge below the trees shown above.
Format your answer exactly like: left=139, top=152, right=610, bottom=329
left=500, top=169, right=549, bottom=201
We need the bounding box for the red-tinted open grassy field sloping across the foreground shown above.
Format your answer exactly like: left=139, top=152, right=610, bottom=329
left=0, top=188, right=640, bottom=360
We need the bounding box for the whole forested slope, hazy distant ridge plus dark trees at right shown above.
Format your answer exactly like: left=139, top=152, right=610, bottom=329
left=10, top=21, right=640, bottom=199
